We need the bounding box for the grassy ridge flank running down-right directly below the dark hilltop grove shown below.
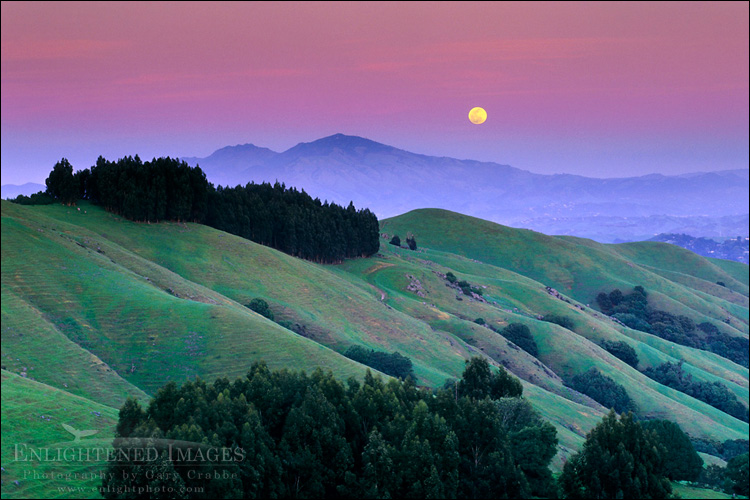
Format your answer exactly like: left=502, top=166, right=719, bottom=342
left=25, top=201, right=476, bottom=385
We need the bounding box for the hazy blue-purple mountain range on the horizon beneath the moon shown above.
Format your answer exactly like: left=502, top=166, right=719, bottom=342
left=183, top=134, right=749, bottom=242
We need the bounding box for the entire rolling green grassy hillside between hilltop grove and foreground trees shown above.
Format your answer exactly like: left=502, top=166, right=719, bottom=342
left=2, top=201, right=749, bottom=497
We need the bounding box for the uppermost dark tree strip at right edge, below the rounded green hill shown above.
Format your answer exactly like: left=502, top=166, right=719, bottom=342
left=596, top=286, right=750, bottom=368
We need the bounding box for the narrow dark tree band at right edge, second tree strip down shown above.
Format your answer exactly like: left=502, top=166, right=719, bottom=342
left=643, top=360, right=750, bottom=422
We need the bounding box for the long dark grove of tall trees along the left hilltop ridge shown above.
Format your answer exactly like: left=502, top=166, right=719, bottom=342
left=29, top=155, right=382, bottom=263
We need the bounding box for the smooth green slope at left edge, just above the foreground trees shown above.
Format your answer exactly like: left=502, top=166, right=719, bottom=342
left=2, top=202, right=382, bottom=400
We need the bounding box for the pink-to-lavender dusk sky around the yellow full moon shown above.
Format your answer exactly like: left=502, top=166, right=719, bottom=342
left=0, top=1, right=750, bottom=184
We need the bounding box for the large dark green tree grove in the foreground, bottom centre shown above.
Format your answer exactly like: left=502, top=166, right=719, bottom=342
left=101, top=358, right=557, bottom=498
